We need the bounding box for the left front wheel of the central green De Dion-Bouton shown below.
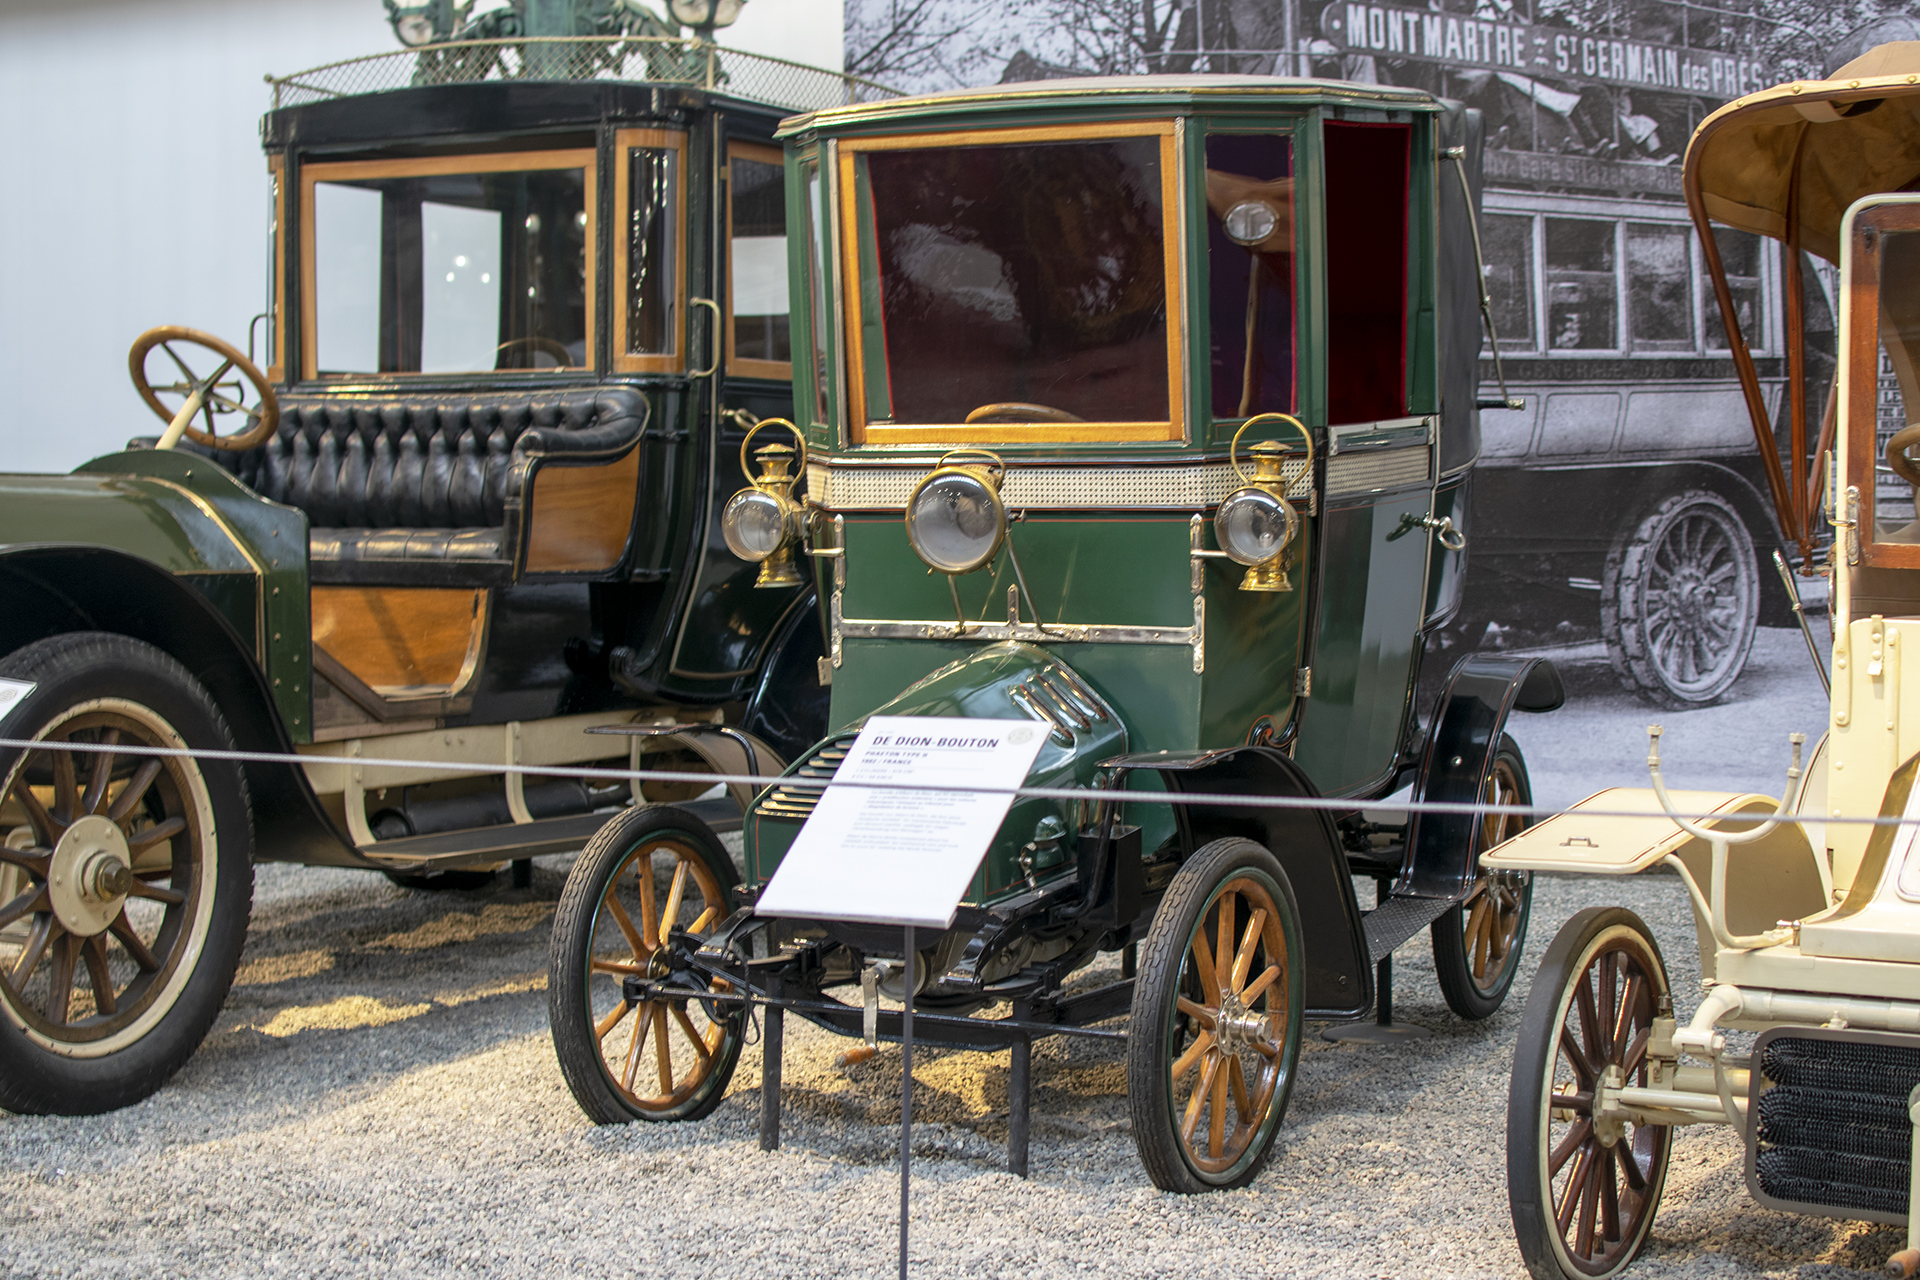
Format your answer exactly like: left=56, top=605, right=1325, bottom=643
left=547, top=806, right=741, bottom=1125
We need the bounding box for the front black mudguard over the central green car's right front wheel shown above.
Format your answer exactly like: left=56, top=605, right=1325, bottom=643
left=1104, top=747, right=1373, bottom=1019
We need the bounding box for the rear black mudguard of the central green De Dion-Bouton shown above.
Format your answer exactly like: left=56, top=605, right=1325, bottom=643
left=1394, top=652, right=1567, bottom=898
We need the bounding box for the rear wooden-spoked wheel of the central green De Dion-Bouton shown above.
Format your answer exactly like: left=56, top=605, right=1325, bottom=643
left=1428, top=733, right=1534, bottom=1021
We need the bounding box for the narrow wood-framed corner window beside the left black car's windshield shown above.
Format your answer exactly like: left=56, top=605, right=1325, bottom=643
left=612, top=129, right=687, bottom=372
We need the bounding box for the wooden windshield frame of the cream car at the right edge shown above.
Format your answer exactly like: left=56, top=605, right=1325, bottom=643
left=1839, top=200, right=1920, bottom=570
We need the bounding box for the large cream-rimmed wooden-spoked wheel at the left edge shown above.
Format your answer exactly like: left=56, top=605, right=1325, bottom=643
left=0, top=633, right=253, bottom=1115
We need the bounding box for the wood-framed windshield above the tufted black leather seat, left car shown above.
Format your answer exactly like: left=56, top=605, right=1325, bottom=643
left=305, top=152, right=593, bottom=378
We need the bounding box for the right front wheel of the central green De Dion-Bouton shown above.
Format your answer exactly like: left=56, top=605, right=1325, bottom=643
left=1127, top=839, right=1304, bottom=1194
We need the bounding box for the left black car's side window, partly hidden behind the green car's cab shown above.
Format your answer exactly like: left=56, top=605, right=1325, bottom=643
left=726, top=142, right=793, bottom=380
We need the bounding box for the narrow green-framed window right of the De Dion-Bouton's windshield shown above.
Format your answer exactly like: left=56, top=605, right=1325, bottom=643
left=1206, top=134, right=1294, bottom=418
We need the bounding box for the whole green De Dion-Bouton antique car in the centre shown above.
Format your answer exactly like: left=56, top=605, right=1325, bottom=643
left=549, top=77, right=1563, bottom=1192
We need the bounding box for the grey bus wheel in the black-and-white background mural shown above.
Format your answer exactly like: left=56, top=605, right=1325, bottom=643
left=1599, top=489, right=1761, bottom=708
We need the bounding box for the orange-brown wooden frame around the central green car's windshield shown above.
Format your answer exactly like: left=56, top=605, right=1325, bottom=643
left=837, top=119, right=1188, bottom=445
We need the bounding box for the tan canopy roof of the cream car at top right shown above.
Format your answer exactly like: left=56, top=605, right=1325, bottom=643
left=1686, top=40, right=1920, bottom=263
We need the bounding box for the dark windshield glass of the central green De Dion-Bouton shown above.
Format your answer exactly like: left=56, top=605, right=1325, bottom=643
left=847, top=125, right=1179, bottom=441
